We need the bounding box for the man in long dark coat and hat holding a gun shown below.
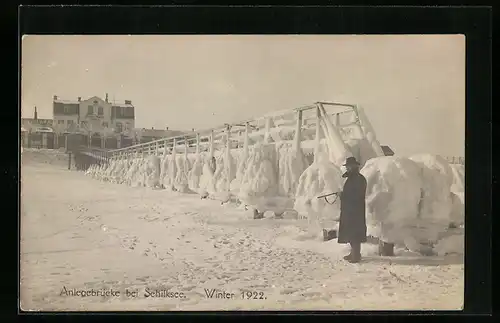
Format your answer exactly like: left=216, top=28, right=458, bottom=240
left=338, top=157, right=366, bottom=263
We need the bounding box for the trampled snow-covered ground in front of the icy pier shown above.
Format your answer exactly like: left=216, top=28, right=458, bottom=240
left=20, top=150, right=464, bottom=311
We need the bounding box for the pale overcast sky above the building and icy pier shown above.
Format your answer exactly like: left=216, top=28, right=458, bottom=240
left=21, top=35, right=465, bottom=156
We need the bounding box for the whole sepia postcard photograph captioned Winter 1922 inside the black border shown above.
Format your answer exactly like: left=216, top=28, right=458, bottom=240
left=19, top=34, right=466, bottom=311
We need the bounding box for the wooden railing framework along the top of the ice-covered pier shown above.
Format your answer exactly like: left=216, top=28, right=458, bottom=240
left=110, top=102, right=376, bottom=159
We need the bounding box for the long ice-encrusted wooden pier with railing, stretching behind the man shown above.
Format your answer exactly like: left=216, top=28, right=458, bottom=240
left=96, top=102, right=383, bottom=215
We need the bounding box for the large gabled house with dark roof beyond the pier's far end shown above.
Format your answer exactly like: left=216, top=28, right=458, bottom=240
left=53, top=94, right=135, bottom=134
